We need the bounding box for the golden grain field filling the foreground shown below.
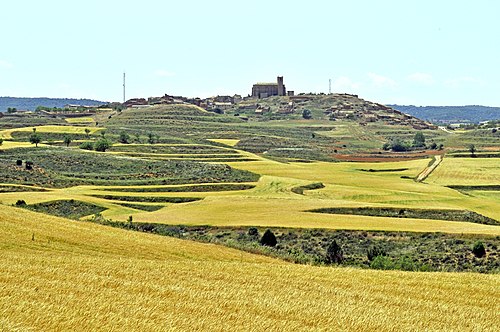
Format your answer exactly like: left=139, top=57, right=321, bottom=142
left=0, top=207, right=500, bottom=331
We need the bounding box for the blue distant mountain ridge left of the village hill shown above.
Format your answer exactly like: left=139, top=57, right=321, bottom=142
left=0, top=97, right=107, bottom=112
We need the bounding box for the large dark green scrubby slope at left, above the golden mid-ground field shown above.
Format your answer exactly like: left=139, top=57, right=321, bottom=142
left=0, top=147, right=259, bottom=188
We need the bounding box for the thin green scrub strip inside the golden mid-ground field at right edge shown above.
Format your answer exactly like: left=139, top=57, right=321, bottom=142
left=307, top=207, right=500, bottom=226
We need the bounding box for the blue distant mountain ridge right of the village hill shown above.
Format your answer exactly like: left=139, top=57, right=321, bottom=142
left=387, top=105, right=500, bottom=124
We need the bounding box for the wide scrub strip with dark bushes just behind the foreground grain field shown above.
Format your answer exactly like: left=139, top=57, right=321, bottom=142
left=94, top=219, right=500, bottom=273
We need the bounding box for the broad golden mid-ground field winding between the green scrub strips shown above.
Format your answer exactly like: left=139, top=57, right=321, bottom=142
left=1, top=156, right=500, bottom=235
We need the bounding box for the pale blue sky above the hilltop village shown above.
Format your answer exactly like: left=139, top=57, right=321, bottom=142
left=0, top=0, right=500, bottom=106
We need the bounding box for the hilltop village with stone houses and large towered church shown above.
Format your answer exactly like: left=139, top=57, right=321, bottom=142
left=119, top=76, right=436, bottom=130
